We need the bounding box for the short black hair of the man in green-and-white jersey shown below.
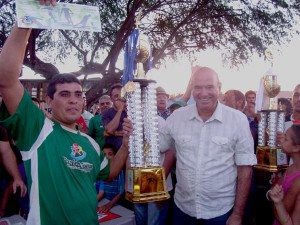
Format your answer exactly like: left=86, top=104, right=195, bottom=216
left=47, top=73, right=81, bottom=99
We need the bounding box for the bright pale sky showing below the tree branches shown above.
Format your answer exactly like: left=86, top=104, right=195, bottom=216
left=24, top=30, right=300, bottom=95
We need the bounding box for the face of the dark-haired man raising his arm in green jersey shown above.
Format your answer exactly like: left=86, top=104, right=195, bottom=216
left=47, top=83, right=84, bottom=128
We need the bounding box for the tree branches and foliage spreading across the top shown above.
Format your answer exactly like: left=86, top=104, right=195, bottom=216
left=0, top=0, right=300, bottom=105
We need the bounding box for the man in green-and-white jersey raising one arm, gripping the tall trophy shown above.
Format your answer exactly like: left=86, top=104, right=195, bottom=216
left=0, top=14, right=132, bottom=225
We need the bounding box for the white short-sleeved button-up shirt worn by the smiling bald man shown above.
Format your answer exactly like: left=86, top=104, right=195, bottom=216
left=159, top=103, right=257, bottom=219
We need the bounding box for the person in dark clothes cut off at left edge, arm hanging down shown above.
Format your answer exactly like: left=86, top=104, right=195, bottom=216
left=0, top=125, right=27, bottom=217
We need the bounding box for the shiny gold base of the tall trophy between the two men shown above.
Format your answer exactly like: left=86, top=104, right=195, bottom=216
left=125, top=167, right=170, bottom=203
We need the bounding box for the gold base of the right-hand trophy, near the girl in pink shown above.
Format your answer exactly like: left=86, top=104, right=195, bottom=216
left=254, top=146, right=288, bottom=173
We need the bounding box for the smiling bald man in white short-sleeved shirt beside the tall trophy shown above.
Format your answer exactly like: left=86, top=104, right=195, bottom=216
left=159, top=67, right=257, bottom=225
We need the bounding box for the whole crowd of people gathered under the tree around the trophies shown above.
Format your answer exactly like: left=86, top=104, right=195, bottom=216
left=0, top=0, right=300, bottom=225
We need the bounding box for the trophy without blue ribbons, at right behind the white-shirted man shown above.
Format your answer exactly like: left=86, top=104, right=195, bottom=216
left=255, top=49, right=288, bottom=172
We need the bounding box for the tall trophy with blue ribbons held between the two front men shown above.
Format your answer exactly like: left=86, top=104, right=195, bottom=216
left=123, top=15, right=170, bottom=202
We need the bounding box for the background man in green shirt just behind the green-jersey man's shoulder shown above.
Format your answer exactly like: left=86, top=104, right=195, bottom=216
left=89, top=95, right=112, bottom=149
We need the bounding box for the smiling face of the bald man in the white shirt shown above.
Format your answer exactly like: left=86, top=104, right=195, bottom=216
left=192, top=69, right=221, bottom=113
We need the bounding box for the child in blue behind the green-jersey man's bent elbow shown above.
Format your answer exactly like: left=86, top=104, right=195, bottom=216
left=96, top=144, right=125, bottom=213
